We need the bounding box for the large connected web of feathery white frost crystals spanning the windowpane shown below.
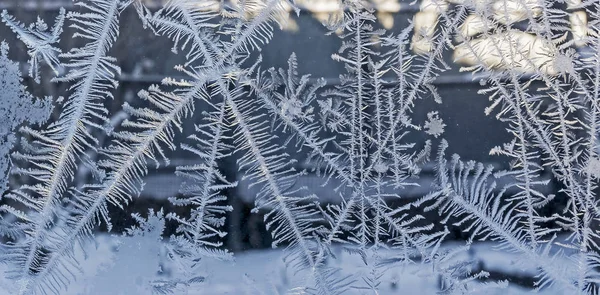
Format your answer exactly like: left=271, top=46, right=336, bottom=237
left=0, top=0, right=600, bottom=295
